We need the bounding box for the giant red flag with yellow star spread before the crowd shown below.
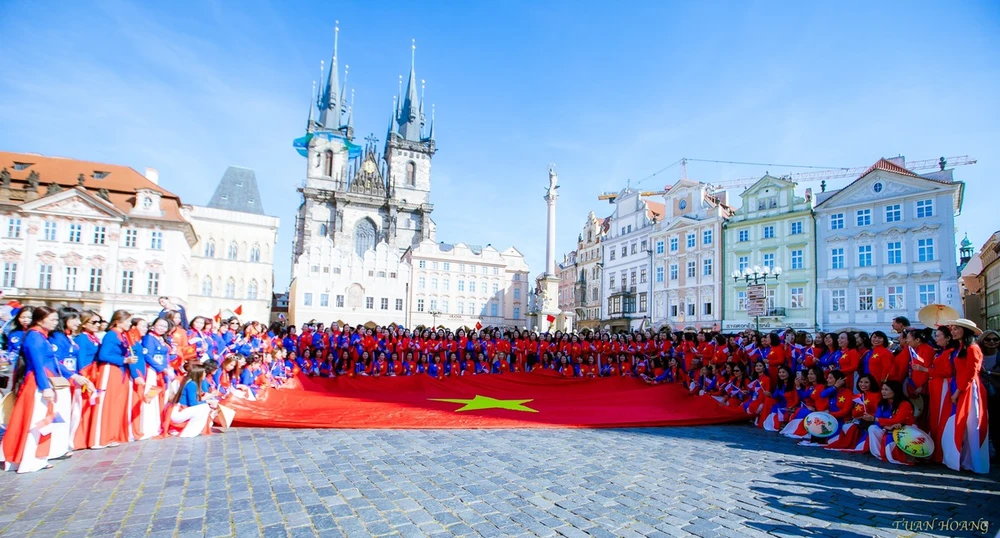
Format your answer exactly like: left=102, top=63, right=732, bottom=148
left=227, top=370, right=747, bottom=429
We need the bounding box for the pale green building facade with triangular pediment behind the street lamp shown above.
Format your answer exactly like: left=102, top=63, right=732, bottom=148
left=720, top=175, right=817, bottom=332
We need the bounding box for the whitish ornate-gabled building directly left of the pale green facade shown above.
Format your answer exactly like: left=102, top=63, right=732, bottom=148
left=639, top=179, right=731, bottom=330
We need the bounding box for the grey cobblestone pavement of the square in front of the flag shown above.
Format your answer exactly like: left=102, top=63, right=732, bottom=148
left=0, top=425, right=1000, bottom=538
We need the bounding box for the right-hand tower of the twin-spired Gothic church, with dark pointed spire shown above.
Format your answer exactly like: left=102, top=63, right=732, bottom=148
left=384, top=42, right=437, bottom=243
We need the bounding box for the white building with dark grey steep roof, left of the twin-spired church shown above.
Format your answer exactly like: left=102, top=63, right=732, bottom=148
left=187, top=166, right=279, bottom=323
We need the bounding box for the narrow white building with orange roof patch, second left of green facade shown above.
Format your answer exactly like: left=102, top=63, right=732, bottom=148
left=601, top=189, right=663, bottom=332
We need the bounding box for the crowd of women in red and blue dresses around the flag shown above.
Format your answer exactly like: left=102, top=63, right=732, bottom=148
left=3, top=307, right=1000, bottom=473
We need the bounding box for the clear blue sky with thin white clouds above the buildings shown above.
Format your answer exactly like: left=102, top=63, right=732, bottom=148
left=0, top=0, right=1000, bottom=288
